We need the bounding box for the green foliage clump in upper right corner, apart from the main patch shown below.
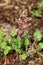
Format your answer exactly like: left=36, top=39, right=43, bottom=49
left=30, top=1, right=43, bottom=17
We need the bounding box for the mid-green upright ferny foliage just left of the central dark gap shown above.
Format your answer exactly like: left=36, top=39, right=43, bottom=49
left=12, top=37, right=22, bottom=53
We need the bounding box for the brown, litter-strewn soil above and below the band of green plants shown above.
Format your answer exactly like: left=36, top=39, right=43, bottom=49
left=0, top=0, right=43, bottom=65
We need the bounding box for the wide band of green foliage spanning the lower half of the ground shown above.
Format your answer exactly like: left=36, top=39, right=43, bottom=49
left=0, top=30, right=43, bottom=60
